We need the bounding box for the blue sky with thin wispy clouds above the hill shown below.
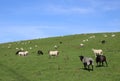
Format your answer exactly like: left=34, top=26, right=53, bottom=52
left=0, top=0, right=120, bottom=43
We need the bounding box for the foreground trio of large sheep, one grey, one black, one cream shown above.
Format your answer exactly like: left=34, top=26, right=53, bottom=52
left=79, top=49, right=108, bottom=71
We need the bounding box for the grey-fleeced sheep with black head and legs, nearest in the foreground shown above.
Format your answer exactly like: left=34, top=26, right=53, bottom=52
left=79, top=56, right=94, bottom=71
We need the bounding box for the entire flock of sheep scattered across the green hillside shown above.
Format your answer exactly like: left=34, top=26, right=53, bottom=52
left=5, top=34, right=115, bottom=70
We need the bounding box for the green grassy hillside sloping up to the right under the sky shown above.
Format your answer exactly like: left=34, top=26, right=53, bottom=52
left=0, top=33, right=120, bottom=81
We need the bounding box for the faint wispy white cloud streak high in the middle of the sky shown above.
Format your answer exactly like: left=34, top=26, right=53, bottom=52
left=45, top=5, right=94, bottom=14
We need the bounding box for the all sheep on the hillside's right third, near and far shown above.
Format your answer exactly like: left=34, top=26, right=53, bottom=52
left=79, top=34, right=115, bottom=71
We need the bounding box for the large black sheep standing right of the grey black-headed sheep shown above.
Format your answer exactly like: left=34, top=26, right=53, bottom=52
left=96, top=55, right=108, bottom=66
